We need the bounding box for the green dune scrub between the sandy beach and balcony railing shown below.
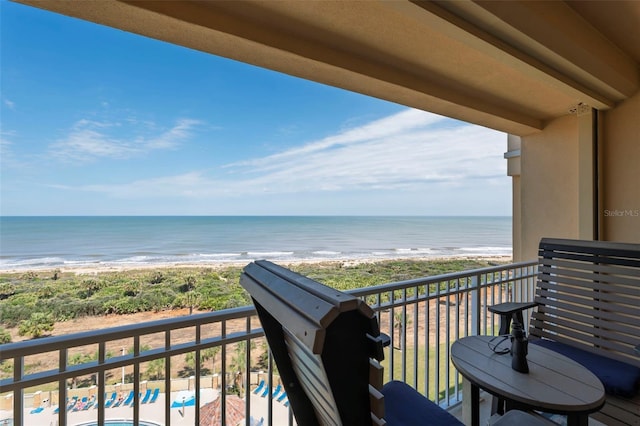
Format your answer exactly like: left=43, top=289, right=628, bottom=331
left=0, top=259, right=508, bottom=337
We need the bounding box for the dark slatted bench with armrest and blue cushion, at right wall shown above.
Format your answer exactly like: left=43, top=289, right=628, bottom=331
left=490, top=238, right=640, bottom=425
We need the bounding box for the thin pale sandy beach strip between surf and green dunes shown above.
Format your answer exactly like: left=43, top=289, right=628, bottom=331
left=0, top=254, right=513, bottom=275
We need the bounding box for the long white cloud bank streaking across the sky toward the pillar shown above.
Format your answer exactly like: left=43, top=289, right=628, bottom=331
left=56, top=110, right=507, bottom=204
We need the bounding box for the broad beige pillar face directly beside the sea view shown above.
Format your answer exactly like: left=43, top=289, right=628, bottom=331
left=514, top=115, right=578, bottom=260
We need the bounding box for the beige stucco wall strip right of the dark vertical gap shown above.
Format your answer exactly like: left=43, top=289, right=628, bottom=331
left=600, top=93, right=640, bottom=243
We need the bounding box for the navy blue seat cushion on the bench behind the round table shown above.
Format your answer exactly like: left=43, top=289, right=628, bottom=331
left=530, top=339, right=640, bottom=398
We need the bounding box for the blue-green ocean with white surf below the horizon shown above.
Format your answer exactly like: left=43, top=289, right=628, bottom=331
left=0, top=216, right=512, bottom=270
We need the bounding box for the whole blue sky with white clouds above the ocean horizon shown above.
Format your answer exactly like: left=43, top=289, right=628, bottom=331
left=0, top=0, right=511, bottom=215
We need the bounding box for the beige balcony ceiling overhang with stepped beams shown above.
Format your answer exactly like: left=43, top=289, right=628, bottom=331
left=17, top=0, right=640, bottom=135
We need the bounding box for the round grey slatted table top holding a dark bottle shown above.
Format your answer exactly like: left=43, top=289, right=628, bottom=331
left=451, top=336, right=605, bottom=413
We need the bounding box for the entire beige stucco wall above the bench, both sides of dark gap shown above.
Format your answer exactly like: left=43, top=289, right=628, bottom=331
left=512, top=94, right=640, bottom=261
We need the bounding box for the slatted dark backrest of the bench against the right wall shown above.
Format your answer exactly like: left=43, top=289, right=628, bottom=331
left=530, top=238, right=640, bottom=365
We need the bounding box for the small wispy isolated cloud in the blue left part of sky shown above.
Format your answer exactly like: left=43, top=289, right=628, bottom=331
left=49, top=119, right=199, bottom=162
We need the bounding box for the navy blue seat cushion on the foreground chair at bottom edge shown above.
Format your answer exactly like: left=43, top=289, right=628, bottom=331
left=382, top=381, right=464, bottom=426
